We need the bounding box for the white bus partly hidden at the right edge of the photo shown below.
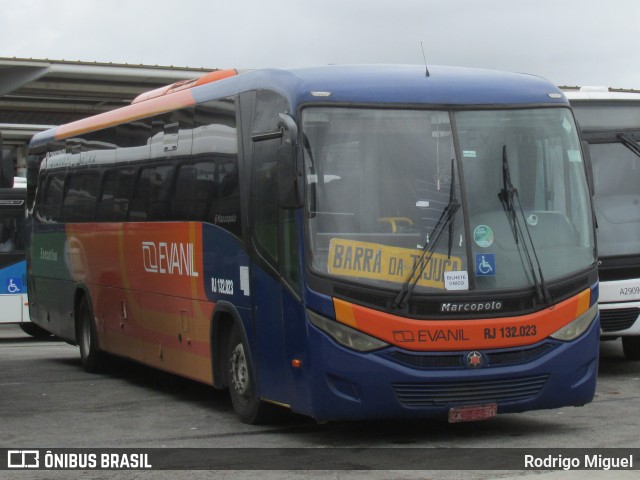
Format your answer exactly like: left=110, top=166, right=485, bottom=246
left=564, top=87, right=640, bottom=360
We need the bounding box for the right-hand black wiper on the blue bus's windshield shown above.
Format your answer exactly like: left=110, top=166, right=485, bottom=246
left=498, top=145, right=551, bottom=304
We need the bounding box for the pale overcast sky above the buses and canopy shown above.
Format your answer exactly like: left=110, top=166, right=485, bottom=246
left=0, top=0, right=640, bottom=89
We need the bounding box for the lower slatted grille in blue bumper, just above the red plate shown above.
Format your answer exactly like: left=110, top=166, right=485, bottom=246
left=393, top=375, right=549, bottom=407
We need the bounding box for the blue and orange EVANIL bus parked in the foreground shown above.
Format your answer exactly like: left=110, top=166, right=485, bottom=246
left=28, top=66, right=600, bottom=423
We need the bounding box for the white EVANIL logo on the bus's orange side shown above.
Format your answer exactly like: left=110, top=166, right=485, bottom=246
left=142, top=242, right=200, bottom=277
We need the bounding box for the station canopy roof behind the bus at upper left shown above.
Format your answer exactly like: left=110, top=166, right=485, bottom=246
left=0, top=57, right=216, bottom=145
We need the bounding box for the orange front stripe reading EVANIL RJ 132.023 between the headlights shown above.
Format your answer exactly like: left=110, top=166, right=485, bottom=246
left=333, top=289, right=591, bottom=351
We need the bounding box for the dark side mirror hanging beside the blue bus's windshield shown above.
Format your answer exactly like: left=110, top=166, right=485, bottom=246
left=278, top=113, right=303, bottom=209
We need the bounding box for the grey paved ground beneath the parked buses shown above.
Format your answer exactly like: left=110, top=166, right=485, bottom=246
left=0, top=326, right=640, bottom=480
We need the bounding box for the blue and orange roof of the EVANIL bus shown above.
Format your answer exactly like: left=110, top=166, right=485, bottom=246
left=31, top=65, right=568, bottom=147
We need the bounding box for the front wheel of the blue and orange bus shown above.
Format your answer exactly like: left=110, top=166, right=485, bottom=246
left=227, top=325, right=273, bottom=425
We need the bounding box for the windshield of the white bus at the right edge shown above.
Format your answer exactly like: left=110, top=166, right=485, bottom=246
left=589, top=143, right=640, bottom=257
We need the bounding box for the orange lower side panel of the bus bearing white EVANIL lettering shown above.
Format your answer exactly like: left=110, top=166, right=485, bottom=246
left=67, top=223, right=213, bottom=383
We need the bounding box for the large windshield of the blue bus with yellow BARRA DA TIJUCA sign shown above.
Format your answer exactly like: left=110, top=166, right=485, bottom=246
left=302, top=107, right=595, bottom=292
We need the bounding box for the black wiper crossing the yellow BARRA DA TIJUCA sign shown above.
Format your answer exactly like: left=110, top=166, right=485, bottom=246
left=393, top=159, right=460, bottom=309
